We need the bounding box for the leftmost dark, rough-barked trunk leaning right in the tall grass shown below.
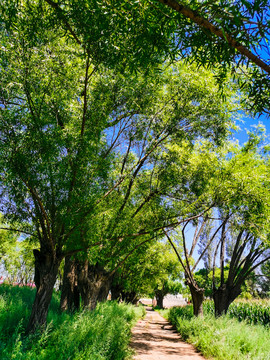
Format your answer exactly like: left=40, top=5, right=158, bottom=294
left=26, top=249, right=61, bottom=334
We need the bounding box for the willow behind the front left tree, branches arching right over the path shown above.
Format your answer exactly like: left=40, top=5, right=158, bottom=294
left=59, top=60, right=236, bottom=309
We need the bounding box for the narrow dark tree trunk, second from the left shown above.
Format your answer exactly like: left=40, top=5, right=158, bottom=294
left=60, top=256, right=80, bottom=312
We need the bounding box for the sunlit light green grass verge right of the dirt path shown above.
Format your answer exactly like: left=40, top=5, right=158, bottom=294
left=165, top=307, right=270, bottom=360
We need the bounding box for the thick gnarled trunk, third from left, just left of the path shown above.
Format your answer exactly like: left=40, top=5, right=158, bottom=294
left=78, top=261, right=111, bottom=310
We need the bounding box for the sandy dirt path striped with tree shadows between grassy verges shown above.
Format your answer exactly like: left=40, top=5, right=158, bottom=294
left=131, top=308, right=205, bottom=360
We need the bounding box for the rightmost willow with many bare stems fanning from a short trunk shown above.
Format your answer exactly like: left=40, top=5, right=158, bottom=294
left=212, top=134, right=270, bottom=316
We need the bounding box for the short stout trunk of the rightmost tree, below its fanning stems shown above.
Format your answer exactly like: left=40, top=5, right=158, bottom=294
left=213, top=284, right=241, bottom=317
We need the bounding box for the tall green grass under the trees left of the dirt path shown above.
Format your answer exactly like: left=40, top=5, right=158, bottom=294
left=0, top=286, right=145, bottom=360
